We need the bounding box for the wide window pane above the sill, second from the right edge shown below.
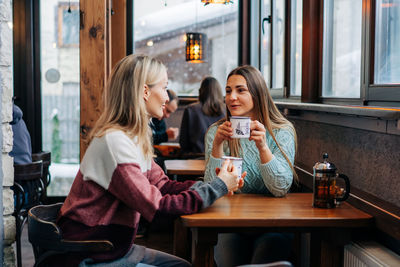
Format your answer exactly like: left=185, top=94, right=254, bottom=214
left=322, top=0, right=363, bottom=98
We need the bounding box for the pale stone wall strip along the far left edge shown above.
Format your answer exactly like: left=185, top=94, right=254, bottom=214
left=0, top=0, right=15, bottom=266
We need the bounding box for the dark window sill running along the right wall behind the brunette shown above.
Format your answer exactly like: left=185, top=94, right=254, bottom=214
left=275, top=101, right=400, bottom=135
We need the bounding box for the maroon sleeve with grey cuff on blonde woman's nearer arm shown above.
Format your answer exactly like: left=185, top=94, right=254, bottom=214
left=108, top=160, right=228, bottom=221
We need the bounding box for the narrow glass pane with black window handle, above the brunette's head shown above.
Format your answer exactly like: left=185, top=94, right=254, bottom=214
left=260, top=0, right=271, bottom=88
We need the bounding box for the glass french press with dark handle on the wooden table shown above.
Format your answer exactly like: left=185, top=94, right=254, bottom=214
left=313, top=153, right=350, bottom=208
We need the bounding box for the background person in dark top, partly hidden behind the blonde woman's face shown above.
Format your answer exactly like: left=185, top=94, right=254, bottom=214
left=150, top=89, right=179, bottom=145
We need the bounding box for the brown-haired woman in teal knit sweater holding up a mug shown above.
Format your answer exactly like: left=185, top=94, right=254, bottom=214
left=204, top=66, right=297, bottom=267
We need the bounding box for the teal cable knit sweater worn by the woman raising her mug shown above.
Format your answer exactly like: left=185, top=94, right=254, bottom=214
left=204, top=123, right=296, bottom=197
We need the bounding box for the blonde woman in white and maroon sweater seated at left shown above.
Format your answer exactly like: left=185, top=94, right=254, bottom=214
left=58, top=55, right=243, bottom=266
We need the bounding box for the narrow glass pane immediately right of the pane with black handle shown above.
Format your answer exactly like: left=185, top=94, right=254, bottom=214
left=272, top=0, right=286, bottom=88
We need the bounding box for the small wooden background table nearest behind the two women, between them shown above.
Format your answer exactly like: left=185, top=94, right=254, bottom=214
left=164, top=159, right=206, bottom=179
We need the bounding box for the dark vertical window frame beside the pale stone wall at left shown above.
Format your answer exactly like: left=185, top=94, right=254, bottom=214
left=13, top=0, right=42, bottom=153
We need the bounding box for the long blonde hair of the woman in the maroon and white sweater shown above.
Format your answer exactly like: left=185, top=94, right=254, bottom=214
left=88, top=55, right=166, bottom=159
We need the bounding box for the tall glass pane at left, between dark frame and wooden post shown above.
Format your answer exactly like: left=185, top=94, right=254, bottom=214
left=40, top=0, right=80, bottom=196
